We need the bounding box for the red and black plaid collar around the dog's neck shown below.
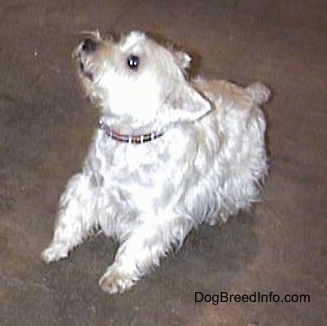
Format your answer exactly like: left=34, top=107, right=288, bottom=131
left=99, top=120, right=164, bottom=144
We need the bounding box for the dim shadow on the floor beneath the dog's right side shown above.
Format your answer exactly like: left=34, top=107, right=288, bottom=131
left=150, top=213, right=258, bottom=295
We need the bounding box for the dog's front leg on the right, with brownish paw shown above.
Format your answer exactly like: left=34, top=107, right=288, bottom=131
left=99, top=217, right=193, bottom=294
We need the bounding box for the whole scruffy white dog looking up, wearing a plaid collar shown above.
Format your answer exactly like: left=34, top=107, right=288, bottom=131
left=42, top=31, right=269, bottom=293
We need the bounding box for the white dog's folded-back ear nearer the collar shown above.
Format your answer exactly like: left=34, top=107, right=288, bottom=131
left=165, top=82, right=211, bottom=122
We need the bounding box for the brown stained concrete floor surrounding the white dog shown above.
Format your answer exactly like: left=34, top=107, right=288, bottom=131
left=0, top=0, right=327, bottom=326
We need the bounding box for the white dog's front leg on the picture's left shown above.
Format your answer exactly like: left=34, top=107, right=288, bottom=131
left=42, top=174, right=96, bottom=263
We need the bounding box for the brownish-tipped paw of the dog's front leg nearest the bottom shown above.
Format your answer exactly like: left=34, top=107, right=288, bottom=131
left=99, top=265, right=135, bottom=294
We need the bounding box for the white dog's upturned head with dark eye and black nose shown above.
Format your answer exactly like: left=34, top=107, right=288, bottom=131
left=74, top=31, right=211, bottom=127
